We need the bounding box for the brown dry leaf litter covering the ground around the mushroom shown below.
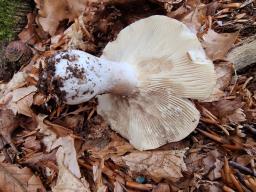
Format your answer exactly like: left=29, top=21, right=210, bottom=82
left=0, top=0, right=256, bottom=192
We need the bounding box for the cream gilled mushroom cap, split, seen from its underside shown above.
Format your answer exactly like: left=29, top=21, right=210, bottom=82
left=97, top=15, right=216, bottom=150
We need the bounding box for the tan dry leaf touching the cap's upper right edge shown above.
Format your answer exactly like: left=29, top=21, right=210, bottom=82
left=202, top=29, right=239, bottom=61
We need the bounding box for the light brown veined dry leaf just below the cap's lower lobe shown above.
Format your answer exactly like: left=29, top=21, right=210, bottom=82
left=111, top=148, right=187, bottom=181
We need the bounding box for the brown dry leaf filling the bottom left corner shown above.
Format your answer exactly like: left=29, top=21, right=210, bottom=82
left=0, top=163, right=46, bottom=192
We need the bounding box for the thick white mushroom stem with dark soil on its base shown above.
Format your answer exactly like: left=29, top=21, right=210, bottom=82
left=45, top=50, right=138, bottom=105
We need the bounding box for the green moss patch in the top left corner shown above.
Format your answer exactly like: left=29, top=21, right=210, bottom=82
left=0, top=0, right=21, bottom=40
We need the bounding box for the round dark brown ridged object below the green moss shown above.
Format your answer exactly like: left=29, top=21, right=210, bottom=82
left=5, top=41, right=33, bottom=66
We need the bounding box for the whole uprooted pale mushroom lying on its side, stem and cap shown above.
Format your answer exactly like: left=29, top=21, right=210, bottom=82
left=42, top=15, right=216, bottom=150
